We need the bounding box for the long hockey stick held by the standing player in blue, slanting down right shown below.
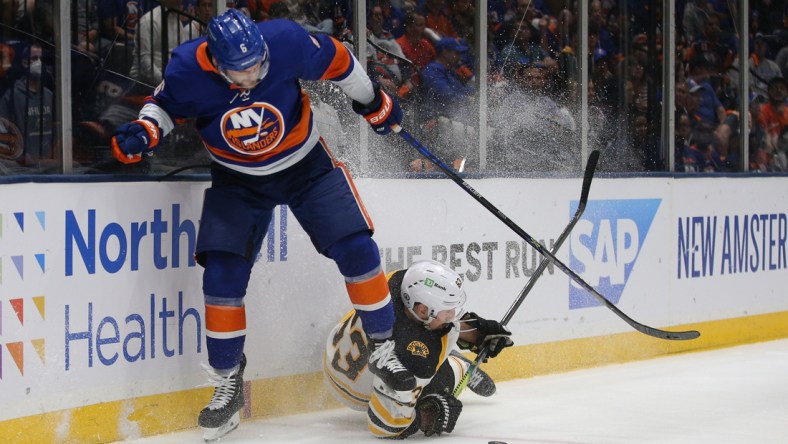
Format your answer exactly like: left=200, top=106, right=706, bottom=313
left=392, top=125, right=700, bottom=340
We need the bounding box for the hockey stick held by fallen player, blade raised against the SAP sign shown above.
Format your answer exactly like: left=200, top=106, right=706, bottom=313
left=452, top=150, right=599, bottom=398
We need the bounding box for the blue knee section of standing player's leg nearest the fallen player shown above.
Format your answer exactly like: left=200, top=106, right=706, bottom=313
left=326, top=232, right=380, bottom=278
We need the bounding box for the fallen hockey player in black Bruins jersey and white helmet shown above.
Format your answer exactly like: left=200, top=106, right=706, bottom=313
left=323, top=261, right=512, bottom=439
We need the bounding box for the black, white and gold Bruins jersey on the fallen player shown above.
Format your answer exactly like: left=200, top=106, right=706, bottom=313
left=323, top=270, right=465, bottom=438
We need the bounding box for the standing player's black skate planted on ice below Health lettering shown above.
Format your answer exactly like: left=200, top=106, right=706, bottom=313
left=197, top=355, right=246, bottom=442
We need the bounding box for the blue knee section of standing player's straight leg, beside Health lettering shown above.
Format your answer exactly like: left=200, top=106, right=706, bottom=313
left=202, top=251, right=252, bottom=305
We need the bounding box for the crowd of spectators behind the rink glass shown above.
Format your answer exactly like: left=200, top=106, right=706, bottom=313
left=0, top=0, right=788, bottom=174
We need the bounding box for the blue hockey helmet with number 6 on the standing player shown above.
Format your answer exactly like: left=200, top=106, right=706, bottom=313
left=208, top=8, right=268, bottom=73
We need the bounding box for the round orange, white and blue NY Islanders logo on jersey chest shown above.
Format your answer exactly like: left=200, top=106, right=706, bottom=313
left=222, top=102, right=285, bottom=156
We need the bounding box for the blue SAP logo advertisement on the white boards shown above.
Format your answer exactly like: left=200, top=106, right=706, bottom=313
left=567, top=199, right=661, bottom=309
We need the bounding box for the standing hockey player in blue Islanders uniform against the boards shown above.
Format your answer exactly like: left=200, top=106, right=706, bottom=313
left=111, top=9, right=416, bottom=440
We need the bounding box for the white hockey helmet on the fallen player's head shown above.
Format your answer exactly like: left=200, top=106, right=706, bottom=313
left=400, top=260, right=467, bottom=325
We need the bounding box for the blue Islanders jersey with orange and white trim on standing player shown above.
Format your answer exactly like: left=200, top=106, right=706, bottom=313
left=140, top=20, right=374, bottom=175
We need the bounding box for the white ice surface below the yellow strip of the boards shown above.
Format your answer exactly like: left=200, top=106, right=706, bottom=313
left=127, top=339, right=788, bottom=444
